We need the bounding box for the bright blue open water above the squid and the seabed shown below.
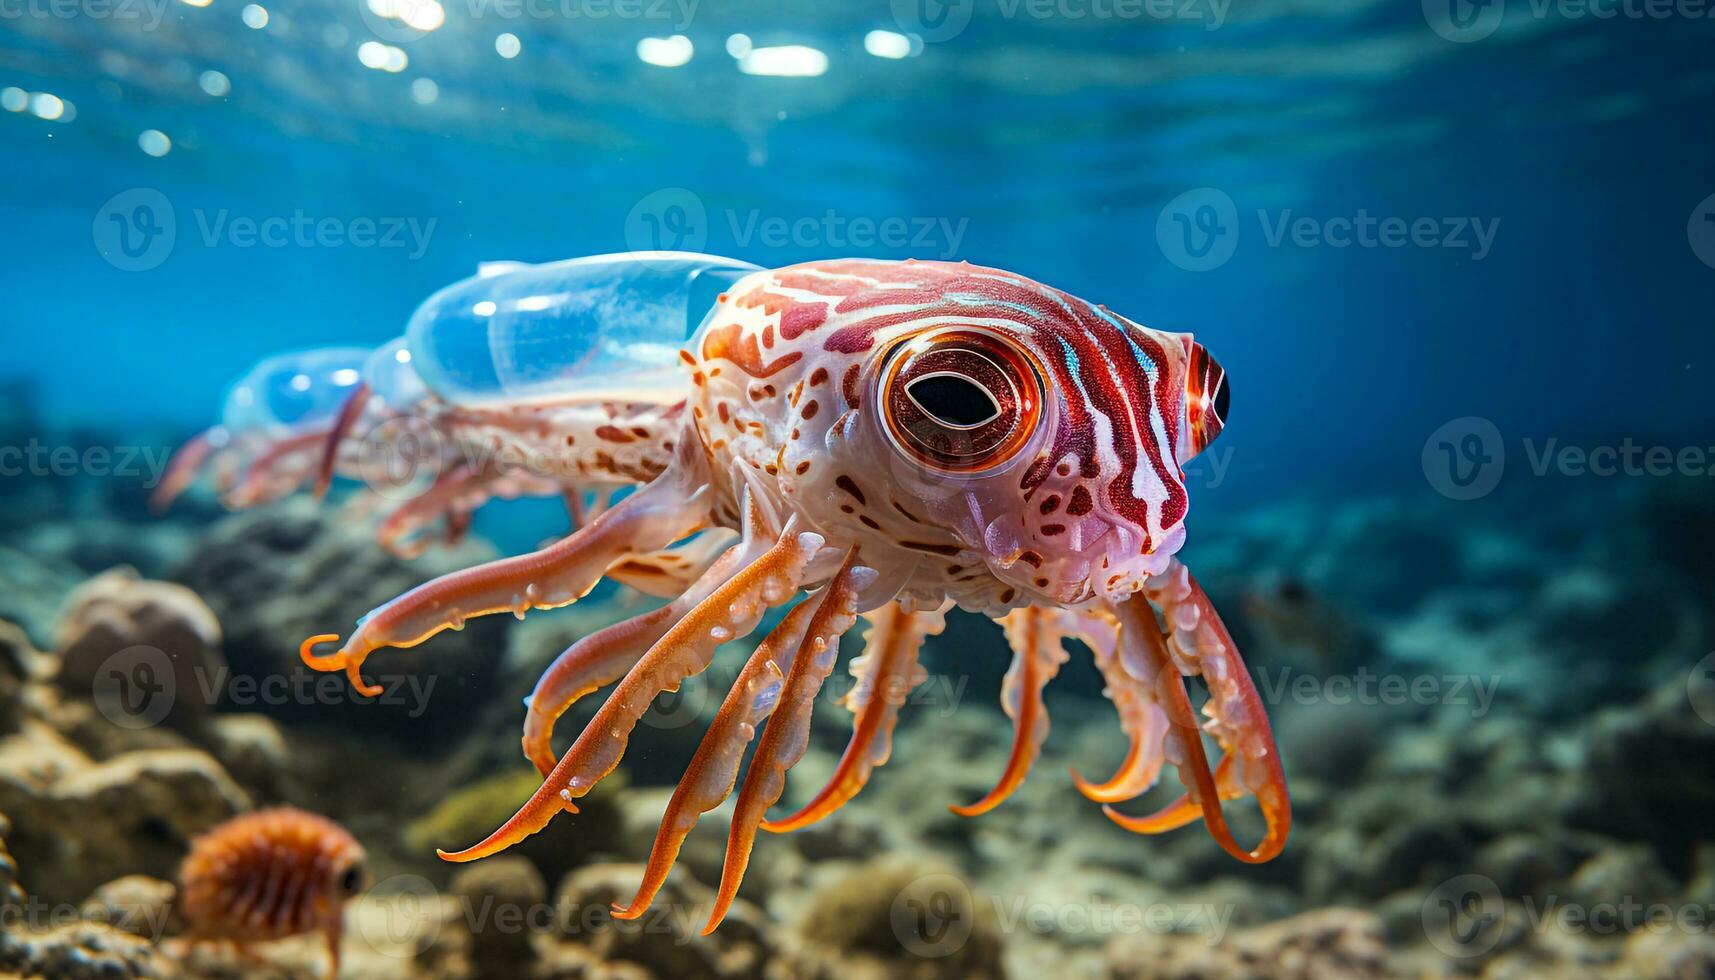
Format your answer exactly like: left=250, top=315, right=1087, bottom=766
left=0, top=0, right=1715, bottom=514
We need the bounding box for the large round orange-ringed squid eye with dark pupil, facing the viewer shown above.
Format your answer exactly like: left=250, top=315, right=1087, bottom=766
left=882, top=328, right=1043, bottom=472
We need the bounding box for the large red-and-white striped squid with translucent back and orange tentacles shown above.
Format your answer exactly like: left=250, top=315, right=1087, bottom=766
left=180, top=252, right=1291, bottom=932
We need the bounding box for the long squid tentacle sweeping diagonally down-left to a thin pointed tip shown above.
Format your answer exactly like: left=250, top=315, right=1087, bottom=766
left=437, top=499, right=823, bottom=862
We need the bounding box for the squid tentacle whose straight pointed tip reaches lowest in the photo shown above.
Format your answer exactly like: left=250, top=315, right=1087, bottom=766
left=703, top=551, right=880, bottom=935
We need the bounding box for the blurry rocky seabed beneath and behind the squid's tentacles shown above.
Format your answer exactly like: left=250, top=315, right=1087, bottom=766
left=0, top=386, right=1715, bottom=980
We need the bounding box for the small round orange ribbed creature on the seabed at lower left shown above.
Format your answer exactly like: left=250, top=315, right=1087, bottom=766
left=177, top=807, right=369, bottom=977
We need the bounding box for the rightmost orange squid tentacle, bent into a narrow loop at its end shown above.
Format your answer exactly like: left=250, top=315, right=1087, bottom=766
left=1103, top=561, right=1291, bottom=863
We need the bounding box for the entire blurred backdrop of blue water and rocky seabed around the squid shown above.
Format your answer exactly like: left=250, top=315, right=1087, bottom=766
left=0, top=0, right=1715, bottom=977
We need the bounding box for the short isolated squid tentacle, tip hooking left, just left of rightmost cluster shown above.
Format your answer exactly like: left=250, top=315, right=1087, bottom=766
left=947, top=606, right=1070, bottom=817
